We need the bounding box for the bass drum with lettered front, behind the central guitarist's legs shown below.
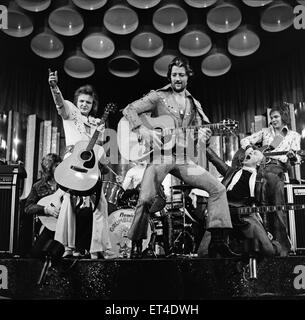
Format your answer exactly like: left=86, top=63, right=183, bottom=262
left=106, top=208, right=151, bottom=259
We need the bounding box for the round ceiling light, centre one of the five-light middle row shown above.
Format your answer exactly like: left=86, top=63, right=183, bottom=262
left=130, top=31, right=163, bottom=58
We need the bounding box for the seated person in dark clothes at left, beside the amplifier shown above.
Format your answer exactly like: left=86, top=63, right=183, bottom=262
left=24, top=153, right=61, bottom=257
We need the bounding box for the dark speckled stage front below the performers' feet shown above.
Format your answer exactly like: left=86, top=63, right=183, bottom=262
left=0, top=256, right=305, bottom=301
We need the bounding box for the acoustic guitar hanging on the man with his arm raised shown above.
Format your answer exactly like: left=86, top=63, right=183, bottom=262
left=54, top=103, right=116, bottom=195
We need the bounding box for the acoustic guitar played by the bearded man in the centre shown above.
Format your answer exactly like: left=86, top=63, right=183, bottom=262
left=117, top=114, right=238, bottom=161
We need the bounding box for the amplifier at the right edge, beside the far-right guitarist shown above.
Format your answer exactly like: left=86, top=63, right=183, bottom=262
left=285, top=184, right=305, bottom=252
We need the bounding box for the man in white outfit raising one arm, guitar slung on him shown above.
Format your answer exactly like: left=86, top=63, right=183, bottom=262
left=49, top=71, right=111, bottom=259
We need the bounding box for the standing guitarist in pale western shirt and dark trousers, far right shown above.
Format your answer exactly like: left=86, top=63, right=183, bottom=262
left=241, top=106, right=301, bottom=256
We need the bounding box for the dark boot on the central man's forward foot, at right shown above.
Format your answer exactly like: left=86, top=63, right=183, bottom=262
left=209, top=228, right=241, bottom=258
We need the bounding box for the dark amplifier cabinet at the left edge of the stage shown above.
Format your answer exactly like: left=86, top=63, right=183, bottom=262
left=0, top=165, right=26, bottom=253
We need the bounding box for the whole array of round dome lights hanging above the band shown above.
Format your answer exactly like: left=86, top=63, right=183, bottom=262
left=3, top=0, right=302, bottom=78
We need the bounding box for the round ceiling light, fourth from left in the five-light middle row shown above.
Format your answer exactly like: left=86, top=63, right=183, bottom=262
left=179, top=30, right=212, bottom=57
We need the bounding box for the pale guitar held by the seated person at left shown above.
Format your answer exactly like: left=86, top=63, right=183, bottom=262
left=37, top=189, right=65, bottom=231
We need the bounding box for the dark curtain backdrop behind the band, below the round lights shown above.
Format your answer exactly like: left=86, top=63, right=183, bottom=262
left=0, top=43, right=305, bottom=133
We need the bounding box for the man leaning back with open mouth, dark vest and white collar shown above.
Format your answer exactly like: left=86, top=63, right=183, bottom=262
left=198, top=147, right=281, bottom=256
